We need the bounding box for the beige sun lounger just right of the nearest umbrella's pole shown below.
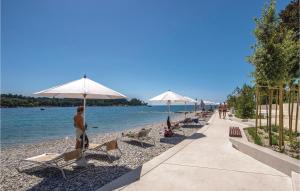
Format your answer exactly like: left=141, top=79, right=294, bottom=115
left=88, top=139, right=122, bottom=160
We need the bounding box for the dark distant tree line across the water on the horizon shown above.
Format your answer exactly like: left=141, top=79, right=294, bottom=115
left=1, top=94, right=147, bottom=107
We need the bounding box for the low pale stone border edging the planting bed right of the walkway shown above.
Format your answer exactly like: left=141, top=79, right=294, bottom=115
left=229, top=138, right=300, bottom=177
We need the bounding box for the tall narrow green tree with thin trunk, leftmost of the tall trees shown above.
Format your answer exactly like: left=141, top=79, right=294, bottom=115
left=249, top=0, right=287, bottom=145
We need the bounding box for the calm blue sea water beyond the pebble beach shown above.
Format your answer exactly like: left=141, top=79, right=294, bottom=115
left=0, top=105, right=199, bottom=147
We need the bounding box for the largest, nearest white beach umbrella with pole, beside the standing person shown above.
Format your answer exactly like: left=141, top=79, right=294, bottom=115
left=34, top=75, right=126, bottom=165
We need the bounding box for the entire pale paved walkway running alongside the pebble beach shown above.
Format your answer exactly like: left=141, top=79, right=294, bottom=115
left=121, top=114, right=292, bottom=191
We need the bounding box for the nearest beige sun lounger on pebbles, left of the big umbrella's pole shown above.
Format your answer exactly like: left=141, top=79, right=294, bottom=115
left=17, top=149, right=82, bottom=179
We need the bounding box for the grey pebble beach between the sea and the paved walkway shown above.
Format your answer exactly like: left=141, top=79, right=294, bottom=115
left=0, top=113, right=208, bottom=190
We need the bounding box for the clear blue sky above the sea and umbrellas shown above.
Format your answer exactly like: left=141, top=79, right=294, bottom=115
left=1, top=0, right=290, bottom=102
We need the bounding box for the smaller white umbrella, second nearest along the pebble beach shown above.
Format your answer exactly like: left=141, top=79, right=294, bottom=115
left=150, top=91, right=187, bottom=115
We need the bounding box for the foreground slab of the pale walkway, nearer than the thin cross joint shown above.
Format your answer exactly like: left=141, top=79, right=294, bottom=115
left=123, top=164, right=292, bottom=191
